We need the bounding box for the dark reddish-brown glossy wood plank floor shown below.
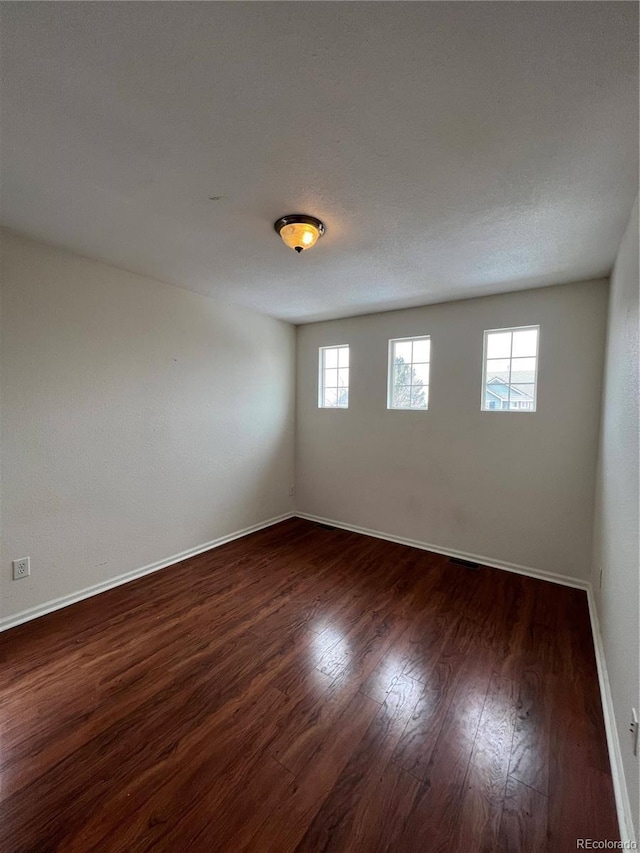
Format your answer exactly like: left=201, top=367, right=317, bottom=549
left=0, top=520, right=619, bottom=853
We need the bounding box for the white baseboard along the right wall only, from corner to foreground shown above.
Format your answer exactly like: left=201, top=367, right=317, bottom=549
left=587, top=585, right=636, bottom=850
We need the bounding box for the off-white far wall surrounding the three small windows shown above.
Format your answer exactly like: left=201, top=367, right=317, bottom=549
left=296, top=281, right=607, bottom=580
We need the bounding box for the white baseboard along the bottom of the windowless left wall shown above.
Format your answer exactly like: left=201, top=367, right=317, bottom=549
left=0, top=512, right=294, bottom=631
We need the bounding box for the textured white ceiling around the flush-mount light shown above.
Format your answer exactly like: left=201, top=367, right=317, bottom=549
left=2, top=2, right=638, bottom=322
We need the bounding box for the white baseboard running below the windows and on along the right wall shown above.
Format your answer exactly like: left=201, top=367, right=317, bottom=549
left=295, top=512, right=636, bottom=849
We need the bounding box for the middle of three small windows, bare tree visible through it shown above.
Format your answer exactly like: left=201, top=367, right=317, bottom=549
left=387, top=335, right=431, bottom=411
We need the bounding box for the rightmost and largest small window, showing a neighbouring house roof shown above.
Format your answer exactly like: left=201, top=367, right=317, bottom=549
left=481, top=326, right=540, bottom=412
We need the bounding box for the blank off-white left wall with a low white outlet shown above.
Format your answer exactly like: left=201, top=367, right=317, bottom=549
left=1, top=232, right=295, bottom=618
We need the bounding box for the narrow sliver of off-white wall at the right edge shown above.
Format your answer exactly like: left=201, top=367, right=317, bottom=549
left=593, top=201, right=640, bottom=837
